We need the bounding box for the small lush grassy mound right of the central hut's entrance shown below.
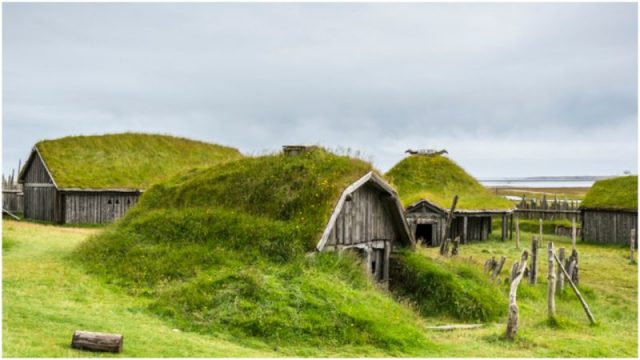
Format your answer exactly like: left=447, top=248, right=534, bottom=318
left=390, top=251, right=507, bottom=321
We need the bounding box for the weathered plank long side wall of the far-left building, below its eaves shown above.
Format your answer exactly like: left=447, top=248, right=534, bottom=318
left=63, top=192, right=139, bottom=224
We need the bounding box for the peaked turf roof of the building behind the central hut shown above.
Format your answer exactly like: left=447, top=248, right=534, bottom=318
left=385, top=155, right=514, bottom=210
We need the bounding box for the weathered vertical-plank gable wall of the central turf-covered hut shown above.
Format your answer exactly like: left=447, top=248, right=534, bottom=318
left=327, top=184, right=398, bottom=245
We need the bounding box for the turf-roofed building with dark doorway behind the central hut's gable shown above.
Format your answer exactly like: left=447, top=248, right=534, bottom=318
left=386, top=153, right=515, bottom=246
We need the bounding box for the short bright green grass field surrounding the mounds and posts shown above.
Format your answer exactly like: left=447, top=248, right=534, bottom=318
left=3, top=220, right=638, bottom=357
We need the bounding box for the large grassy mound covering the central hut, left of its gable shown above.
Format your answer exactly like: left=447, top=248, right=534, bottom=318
left=77, top=149, right=430, bottom=354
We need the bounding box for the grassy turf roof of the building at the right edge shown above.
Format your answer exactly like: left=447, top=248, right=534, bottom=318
left=580, top=175, right=638, bottom=211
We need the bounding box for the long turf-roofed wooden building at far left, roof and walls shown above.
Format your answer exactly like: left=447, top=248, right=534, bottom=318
left=19, top=133, right=242, bottom=224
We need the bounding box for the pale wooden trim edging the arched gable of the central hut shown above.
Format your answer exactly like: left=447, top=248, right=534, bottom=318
left=316, top=171, right=415, bottom=251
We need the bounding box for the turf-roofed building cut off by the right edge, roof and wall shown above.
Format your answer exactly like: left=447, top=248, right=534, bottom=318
left=580, top=176, right=638, bottom=245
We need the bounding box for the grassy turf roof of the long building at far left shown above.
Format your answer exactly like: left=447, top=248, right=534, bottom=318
left=36, top=133, right=242, bottom=189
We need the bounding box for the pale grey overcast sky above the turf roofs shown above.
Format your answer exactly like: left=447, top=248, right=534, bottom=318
left=2, top=3, right=638, bottom=178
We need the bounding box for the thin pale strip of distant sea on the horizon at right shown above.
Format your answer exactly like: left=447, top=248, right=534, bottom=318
left=480, top=176, right=612, bottom=188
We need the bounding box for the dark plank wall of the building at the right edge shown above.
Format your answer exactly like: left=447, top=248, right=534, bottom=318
left=582, top=209, right=638, bottom=244
